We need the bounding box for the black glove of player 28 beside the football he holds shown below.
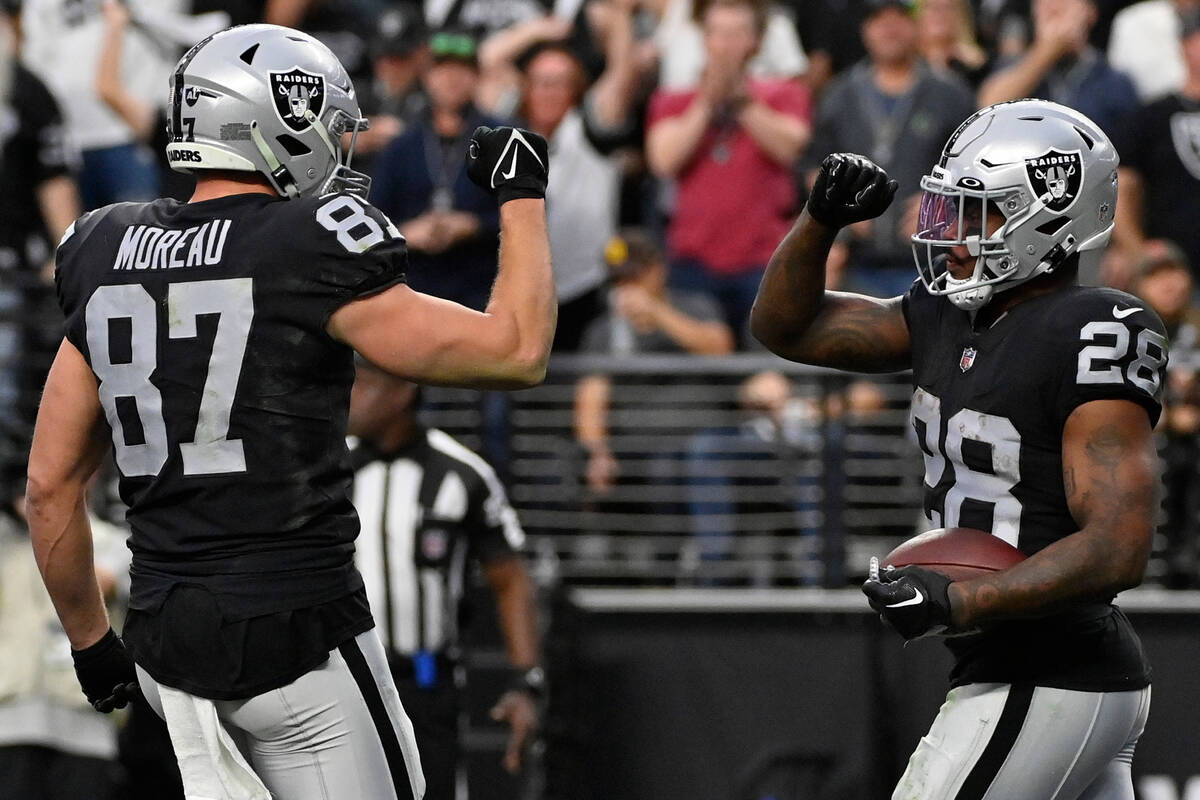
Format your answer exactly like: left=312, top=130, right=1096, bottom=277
left=863, top=566, right=952, bottom=639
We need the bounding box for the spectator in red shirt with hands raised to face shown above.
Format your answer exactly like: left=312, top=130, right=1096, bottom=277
left=646, top=0, right=811, bottom=341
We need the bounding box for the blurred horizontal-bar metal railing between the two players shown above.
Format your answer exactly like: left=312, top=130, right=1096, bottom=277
left=425, top=355, right=922, bottom=587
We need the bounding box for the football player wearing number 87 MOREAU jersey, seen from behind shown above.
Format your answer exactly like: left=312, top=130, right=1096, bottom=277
left=29, top=25, right=556, bottom=800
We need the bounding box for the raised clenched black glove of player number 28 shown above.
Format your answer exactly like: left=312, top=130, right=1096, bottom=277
left=808, top=152, right=899, bottom=228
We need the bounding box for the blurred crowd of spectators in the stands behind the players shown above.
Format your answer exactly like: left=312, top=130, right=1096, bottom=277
left=0, top=0, right=1200, bottom=587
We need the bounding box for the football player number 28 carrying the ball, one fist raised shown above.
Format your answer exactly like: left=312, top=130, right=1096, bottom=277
left=751, top=101, right=1166, bottom=800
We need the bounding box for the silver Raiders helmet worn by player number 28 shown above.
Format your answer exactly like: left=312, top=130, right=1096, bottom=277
left=912, top=100, right=1118, bottom=311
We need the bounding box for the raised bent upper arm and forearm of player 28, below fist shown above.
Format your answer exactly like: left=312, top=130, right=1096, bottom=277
left=750, top=211, right=911, bottom=372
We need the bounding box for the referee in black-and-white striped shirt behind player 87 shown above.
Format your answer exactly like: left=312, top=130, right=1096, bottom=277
left=349, top=360, right=544, bottom=800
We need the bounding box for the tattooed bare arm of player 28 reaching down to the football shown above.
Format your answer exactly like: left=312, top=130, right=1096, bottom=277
left=949, top=399, right=1158, bottom=628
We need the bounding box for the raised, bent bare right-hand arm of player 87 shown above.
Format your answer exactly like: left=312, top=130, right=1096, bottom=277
left=329, top=199, right=558, bottom=389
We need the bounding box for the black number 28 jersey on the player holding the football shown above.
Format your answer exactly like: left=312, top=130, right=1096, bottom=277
left=904, top=282, right=1168, bottom=691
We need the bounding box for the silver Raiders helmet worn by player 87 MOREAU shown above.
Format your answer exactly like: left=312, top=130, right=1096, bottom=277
left=167, top=25, right=371, bottom=198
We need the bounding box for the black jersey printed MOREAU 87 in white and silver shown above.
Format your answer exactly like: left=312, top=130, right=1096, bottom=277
left=56, top=194, right=406, bottom=619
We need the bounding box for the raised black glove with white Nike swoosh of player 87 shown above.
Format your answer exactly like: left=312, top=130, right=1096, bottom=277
left=467, top=125, right=550, bottom=205
